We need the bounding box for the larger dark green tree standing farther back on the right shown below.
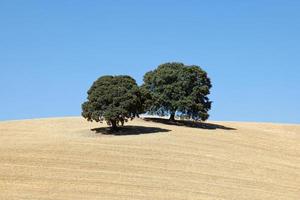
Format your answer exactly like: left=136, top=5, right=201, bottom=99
left=142, top=62, right=212, bottom=121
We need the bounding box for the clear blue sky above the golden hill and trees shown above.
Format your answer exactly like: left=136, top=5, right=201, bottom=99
left=0, top=0, right=300, bottom=123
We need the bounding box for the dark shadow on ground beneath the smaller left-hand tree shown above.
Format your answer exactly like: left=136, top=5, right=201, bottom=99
left=91, top=125, right=171, bottom=136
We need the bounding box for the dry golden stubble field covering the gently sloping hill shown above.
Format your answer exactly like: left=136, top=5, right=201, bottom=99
left=0, top=117, right=300, bottom=200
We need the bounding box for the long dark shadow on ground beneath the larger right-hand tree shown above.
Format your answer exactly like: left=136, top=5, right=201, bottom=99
left=144, top=117, right=236, bottom=130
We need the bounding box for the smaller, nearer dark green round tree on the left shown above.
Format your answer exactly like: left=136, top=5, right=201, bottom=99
left=82, top=76, right=144, bottom=131
